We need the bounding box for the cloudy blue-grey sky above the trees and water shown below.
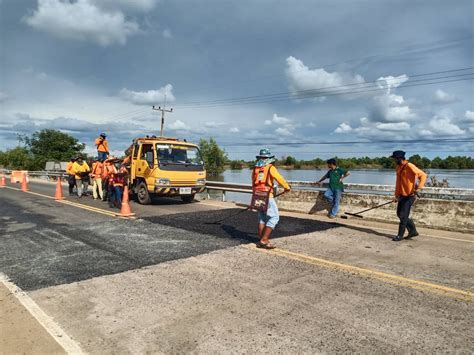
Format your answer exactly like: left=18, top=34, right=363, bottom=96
left=0, top=0, right=474, bottom=159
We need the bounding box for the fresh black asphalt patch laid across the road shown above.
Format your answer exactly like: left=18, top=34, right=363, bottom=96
left=0, top=185, right=337, bottom=290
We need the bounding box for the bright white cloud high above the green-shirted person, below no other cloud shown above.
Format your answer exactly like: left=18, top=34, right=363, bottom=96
left=285, top=56, right=365, bottom=98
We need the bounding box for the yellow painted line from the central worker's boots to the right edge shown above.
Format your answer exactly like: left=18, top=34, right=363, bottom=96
left=242, top=244, right=474, bottom=302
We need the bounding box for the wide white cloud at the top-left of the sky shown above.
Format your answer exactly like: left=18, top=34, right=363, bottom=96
left=24, top=0, right=140, bottom=47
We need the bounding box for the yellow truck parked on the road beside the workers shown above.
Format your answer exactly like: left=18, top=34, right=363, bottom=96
left=125, top=136, right=206, bottom=205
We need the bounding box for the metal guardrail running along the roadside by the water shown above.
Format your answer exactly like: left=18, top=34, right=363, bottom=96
left=0, top=169, right=474, bottom=201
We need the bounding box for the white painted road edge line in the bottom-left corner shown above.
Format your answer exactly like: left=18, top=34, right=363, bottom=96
left=0, top=272, right=84, bottom=355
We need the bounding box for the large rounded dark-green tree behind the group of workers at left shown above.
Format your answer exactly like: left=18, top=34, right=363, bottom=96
left=20, top=129, right=84, bottom=170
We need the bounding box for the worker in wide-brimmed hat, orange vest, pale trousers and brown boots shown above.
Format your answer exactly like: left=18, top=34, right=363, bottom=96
left=251, top=149, right=290, bottom=249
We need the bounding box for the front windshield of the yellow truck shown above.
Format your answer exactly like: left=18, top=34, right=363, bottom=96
left=156, top=144, right=204, bottom=166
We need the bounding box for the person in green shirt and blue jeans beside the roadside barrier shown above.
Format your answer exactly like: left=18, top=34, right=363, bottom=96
left=316, top=158, right=351, bottom=219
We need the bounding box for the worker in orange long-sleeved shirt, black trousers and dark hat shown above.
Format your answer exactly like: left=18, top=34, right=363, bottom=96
left=391, top=150, right=426, bottom=242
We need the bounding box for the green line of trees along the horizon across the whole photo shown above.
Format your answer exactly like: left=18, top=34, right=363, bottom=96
left=0, top=129, right=474, bottom=175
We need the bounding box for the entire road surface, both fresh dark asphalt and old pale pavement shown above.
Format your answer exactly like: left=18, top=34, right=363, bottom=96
left=0, top=182, right=474, bottom=354
